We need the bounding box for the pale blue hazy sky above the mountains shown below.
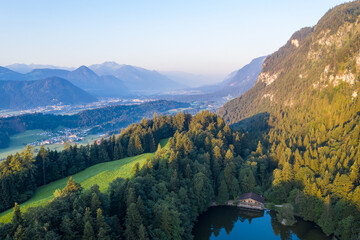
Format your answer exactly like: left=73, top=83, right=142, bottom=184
left=0, top=0, right=344, bottom=75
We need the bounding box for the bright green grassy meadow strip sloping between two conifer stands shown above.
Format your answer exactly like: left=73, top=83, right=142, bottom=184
left=0, top=145, right=163, bottom=222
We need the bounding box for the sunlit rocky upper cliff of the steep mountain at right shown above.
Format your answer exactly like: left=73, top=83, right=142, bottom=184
left=219, top=1, right=360, bottom=124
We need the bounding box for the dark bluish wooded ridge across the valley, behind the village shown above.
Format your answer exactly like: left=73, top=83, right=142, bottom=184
left=0, top=100, right=189, bottom=148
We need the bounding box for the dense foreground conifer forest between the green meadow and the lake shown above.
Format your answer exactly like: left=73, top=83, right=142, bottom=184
left=0, top=112, right=264, bottom=240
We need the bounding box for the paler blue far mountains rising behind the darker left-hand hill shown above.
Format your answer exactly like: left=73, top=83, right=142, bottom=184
left=0, top=62, right=186, bottom=97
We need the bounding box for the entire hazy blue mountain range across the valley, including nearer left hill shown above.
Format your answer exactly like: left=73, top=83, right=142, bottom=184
left=0, top=57, right=265, bottom=109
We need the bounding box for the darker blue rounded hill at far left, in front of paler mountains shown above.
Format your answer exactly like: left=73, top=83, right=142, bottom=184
left=0, top=77, right=97, bottom=109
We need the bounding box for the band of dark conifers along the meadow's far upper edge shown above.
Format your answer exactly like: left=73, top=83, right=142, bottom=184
left=0, top=113, right=190, bottom=211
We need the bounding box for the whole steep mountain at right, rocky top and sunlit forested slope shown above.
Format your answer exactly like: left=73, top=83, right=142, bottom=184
left=218, top=1, right=360, bottom=239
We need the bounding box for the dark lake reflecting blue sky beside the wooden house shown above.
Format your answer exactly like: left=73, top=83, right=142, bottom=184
left=193, top=206, right=331, bottom=240
